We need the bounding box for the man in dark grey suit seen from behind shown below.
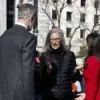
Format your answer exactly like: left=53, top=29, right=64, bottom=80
left=0, top=4, right=36, bottom=100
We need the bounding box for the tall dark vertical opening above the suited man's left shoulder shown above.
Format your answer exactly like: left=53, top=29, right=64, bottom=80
left=7, top=0, right=15, bottom=29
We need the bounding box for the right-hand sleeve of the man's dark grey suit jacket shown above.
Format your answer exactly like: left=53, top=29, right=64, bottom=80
left=22, top=36, right=36, bottom=100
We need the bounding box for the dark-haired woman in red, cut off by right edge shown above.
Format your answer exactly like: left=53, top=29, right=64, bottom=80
left=78, top=32, right=100, bottom=100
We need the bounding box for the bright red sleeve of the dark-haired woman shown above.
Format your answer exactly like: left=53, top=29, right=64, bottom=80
left=84, top=57, right=99, bottom=100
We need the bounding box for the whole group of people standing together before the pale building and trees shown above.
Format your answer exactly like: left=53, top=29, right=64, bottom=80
left=0, top=3, right=100, bottom=100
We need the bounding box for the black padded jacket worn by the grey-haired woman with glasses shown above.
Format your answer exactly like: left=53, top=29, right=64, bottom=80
left=40, top=51, right=76, bottom=100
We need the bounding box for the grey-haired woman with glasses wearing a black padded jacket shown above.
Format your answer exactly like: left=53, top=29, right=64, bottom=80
left=40, top=28, right=76, bottom=100
